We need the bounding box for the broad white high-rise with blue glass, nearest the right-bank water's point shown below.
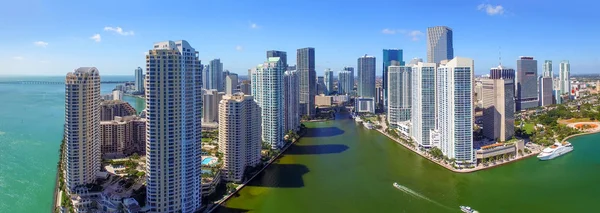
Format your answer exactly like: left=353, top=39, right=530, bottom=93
left=436, top=57, right=476, bottom=164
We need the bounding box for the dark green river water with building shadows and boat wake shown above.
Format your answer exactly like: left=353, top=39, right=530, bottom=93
left=219, top=115, right=600, bottom=213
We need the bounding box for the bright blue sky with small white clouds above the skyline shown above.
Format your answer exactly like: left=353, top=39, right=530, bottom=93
left=0, top=0, right=600, bottom=75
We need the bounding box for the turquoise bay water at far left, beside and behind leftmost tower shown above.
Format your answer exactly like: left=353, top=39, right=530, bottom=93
left=0, top=76, right=145, bottom=213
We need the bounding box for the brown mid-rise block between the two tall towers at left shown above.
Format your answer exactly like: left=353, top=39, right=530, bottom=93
left=100, top=115, right=146, bottom=158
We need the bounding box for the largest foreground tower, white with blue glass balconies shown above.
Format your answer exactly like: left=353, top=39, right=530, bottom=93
left=146, top=40, right=203, bottom=213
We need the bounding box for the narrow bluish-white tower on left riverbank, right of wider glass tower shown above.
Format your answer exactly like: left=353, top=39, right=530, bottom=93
left=283, top=70, right=300, bottom=134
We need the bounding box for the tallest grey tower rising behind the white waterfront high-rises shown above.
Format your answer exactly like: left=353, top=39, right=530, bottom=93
left=427, top=26, right=454, bottom=63
